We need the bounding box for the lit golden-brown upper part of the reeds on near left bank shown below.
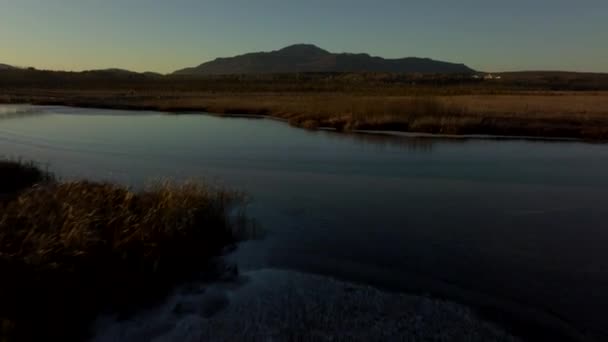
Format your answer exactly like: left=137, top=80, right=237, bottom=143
left=0, top=182, right=238, bottom=272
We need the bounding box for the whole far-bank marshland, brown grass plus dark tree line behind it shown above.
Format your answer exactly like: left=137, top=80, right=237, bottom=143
left=0, top=71, right=608, bottom=140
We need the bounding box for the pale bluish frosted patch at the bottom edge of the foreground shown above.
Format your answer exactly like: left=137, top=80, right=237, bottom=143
left=94, top=269, right=519, bottom=342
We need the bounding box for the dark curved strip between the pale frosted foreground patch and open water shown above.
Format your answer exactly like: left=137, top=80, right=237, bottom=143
left=279, top=254, right=596, bottom=342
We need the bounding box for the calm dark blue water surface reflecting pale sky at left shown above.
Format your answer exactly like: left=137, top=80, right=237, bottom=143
left=0, top=106, right=608, bottom=340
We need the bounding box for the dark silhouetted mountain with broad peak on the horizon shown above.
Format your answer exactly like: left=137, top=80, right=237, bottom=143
left=174, top=44, right=475, bottom=75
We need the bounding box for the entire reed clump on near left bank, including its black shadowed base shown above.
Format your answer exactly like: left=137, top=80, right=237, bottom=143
left=0, top=162, right=249, bottom=340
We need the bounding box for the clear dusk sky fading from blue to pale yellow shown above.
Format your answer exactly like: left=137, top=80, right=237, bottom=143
left=0, top=0, right=608, bottom=72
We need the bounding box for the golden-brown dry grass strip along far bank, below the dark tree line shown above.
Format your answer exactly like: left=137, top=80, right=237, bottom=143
left=3, top=91, right=608, bottom=139
